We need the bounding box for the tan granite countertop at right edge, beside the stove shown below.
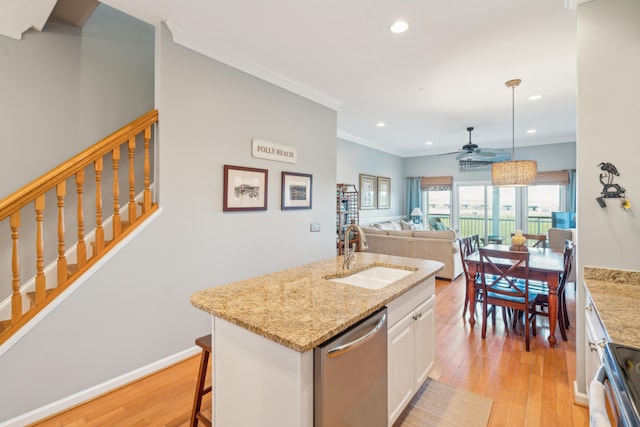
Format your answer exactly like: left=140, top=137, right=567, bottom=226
left=583, top=267, right=640, bottom=348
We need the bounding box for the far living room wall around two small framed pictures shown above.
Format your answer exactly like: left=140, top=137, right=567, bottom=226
left=336, top=139, right=405, bottom=224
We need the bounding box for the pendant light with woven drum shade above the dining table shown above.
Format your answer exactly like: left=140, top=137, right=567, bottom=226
left=491, top=79, right=538, bottom=187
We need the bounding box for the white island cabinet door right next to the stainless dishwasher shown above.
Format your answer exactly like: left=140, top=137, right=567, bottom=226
left=387, top=313, right=416, bottom=425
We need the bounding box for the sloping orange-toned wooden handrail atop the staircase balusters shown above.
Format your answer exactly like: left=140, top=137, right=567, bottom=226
left=0, top=110, right=158, bottom=221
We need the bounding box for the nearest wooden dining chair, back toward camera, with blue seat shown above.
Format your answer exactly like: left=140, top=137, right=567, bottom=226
left=479, top=248, right=537, bottom=351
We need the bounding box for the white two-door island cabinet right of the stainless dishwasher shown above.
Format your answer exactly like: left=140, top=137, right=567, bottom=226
left=387, top=279, right=436, bottom=426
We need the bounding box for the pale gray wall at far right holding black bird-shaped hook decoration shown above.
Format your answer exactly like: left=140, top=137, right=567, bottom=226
left=576, top=0, right=640, bottom=392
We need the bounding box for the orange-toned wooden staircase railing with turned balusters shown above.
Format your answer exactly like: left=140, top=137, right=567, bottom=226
left=0, top=110, right=158, bottom=345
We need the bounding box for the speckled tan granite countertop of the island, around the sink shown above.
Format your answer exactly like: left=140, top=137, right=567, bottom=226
left=191, top=252, right=444, bottom=352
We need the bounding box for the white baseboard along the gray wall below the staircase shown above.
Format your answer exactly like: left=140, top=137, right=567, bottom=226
left=0, top=346, right=201, bottom=427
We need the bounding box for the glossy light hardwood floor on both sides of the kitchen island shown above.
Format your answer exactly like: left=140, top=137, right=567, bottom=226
left=35, top=278, right=589, bottom=427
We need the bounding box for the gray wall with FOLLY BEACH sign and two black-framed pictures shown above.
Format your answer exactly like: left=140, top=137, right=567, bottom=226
left=0, top=10, right=336, bottom=421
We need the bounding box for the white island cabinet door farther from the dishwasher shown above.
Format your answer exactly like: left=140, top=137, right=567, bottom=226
left=414, top=295, right=436, bottom=391
